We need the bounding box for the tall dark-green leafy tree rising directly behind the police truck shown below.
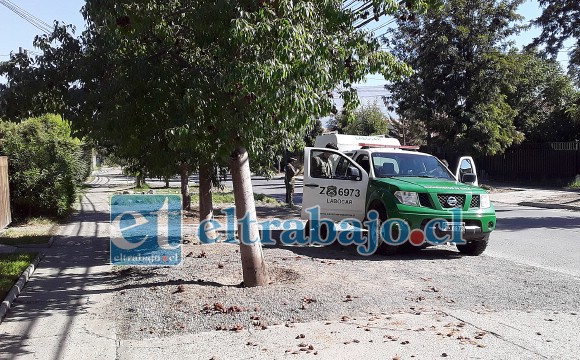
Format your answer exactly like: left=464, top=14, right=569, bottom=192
left=386, top=0, right=523, bottom=154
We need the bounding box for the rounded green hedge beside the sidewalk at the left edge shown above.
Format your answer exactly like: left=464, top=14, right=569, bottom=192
left=0, top=115, right=90, bottom=218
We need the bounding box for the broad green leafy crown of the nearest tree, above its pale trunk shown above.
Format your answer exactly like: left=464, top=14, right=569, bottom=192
left=0, top=0, right=434, bottom=167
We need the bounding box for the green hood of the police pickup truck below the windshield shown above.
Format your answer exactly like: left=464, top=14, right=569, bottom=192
left=372, top=176, right=486, bottom=194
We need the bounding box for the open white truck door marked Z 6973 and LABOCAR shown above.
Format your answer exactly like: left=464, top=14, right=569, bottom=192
left=301, top=147, right=369, bottom=221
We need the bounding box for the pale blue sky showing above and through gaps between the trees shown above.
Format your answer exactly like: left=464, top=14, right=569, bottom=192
left=0, top=0, right=567, bottom=111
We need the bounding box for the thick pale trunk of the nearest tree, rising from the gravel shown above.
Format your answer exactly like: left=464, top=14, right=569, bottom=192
left=230, top=148, right=268, bottom=287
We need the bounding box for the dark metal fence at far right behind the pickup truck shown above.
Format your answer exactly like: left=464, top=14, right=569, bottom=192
left=425, top=142, right=580, bottom=183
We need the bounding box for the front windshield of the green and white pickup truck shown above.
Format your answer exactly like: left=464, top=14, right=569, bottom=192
left=372, top=153, right=455, bottom=181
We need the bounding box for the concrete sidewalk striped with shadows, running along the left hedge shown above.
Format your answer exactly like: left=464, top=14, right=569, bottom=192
left=0, top=183, right=116, bottom=359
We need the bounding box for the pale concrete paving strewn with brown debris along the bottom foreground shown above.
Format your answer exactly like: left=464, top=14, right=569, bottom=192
left=118, top=310, right=580, bottom=360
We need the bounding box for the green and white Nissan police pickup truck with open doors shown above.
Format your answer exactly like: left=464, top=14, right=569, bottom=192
left=301, top=134, right=496, bottom=255
